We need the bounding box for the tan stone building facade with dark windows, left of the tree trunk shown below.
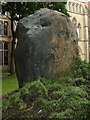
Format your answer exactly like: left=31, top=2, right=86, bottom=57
left=0, top=2, right=12, bottom=73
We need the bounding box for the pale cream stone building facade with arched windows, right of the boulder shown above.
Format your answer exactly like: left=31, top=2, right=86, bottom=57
left=66, top=0, right=90, bottom=62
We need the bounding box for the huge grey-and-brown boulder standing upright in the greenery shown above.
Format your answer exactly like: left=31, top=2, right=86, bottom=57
left=15, top=8, right=78, bottom=87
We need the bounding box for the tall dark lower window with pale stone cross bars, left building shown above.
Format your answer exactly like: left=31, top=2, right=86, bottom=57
left=0, top=41, right=8, bottom=66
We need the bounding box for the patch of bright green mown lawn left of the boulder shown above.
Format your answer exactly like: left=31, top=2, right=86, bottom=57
left=2, top=75, right=18, bottom=96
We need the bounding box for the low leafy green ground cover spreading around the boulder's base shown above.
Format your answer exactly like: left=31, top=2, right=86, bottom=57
left=3, top=59, right=90, bottom=120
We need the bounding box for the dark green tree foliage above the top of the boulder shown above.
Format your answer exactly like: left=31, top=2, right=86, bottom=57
left=3, top=2, right=69, bottom=20
